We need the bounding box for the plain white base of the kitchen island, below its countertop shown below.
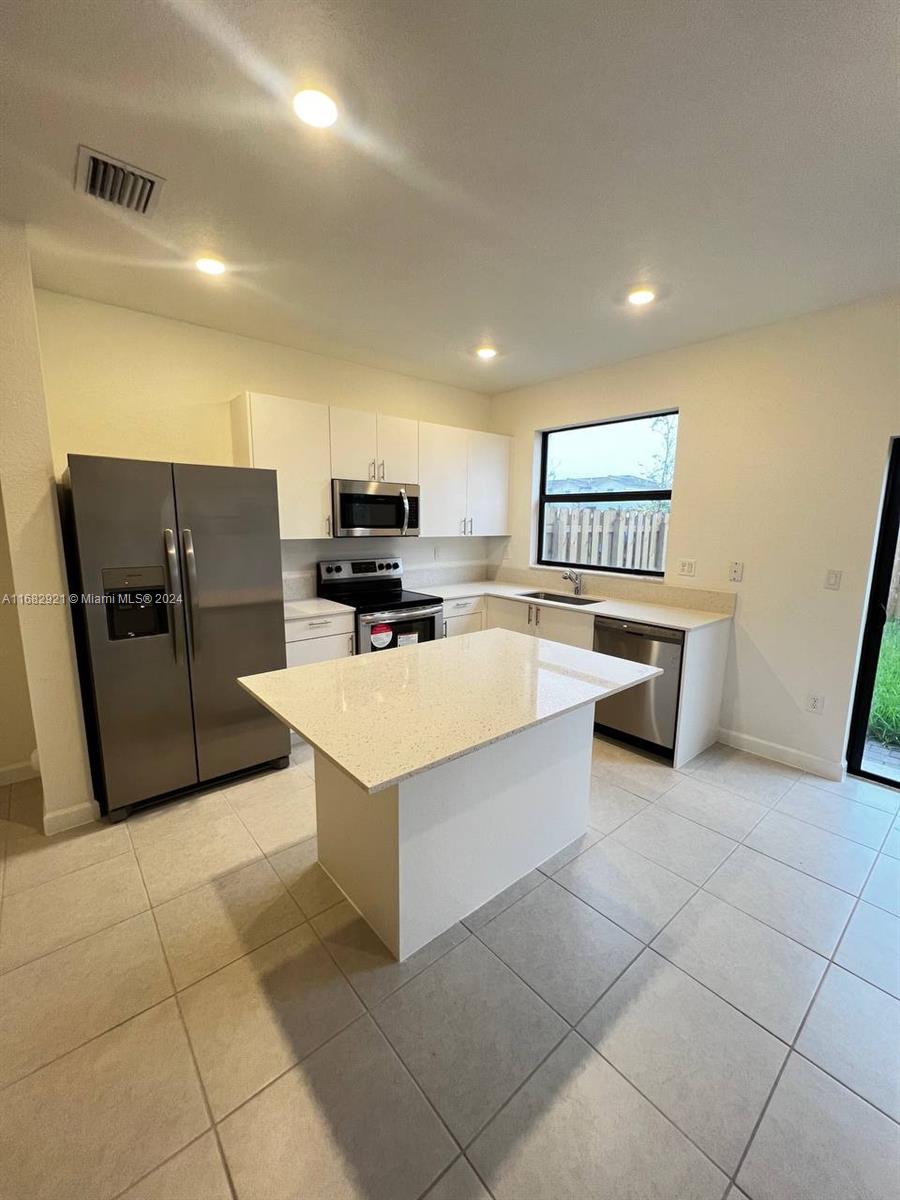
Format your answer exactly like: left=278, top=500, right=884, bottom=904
left=316, top=703, right=594, bottom=959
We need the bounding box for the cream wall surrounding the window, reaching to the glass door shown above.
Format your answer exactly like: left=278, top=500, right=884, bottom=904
left=493, top=296, right=900, bottom=769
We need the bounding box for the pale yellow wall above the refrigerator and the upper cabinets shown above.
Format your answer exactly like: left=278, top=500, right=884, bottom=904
left=35, top=290, right=490, bottom=474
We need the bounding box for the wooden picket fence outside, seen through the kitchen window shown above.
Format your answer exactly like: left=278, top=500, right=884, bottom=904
left=544, top=504, right=668, bottom=571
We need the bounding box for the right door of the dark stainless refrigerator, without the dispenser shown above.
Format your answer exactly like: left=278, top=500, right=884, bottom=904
left=174, top=463, right=290, bottom=779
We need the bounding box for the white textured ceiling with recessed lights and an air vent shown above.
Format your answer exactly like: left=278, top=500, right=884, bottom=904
left=0, top=0, right=900, bottom=391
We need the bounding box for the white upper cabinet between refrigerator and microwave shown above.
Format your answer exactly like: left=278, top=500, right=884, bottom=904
left=232, top=391, right=331, bottom=541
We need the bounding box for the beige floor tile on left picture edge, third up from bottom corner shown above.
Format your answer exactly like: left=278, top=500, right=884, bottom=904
left=0, top=854, right=149, bottom=971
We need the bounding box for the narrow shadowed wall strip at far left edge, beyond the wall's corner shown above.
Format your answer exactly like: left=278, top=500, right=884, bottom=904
left=0, top=482, right=35, bottom=772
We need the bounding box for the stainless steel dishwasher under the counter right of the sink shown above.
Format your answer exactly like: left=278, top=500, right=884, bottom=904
left=594, top=617, right=684, bottom=752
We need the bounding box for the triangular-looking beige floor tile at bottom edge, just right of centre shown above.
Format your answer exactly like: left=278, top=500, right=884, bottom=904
left=467, top=1033, right=727, bottom=1200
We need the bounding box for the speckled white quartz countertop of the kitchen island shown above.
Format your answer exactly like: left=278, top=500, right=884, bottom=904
left=239, top=629, right=661, bottom=792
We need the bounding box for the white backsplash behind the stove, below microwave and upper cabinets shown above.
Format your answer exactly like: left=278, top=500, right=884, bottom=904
left=281, top=538, right=508, bottom=600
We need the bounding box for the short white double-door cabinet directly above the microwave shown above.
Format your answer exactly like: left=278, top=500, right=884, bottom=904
left=330, top=407, right=419, bottom=484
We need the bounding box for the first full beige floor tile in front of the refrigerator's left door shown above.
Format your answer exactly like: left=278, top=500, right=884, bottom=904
left=136, top=812, right=262, bottom=905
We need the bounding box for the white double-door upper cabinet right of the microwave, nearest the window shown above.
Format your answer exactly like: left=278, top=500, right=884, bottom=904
left=419, top=421, right=510, bottom=538
